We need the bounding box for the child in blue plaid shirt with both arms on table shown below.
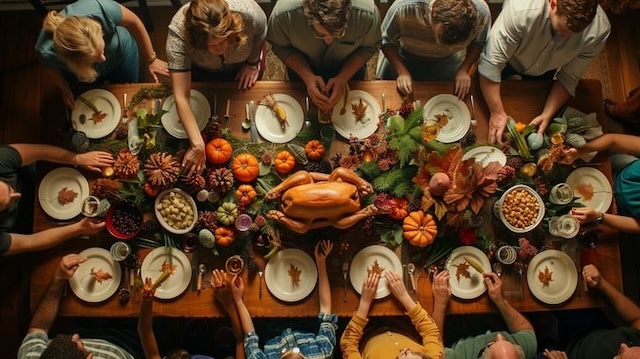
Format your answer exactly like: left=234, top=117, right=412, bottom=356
left=231, top=240, right=338, bottom=359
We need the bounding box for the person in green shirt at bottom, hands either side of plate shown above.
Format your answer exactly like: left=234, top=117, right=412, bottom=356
left=432, top=271, right=537, bottom=359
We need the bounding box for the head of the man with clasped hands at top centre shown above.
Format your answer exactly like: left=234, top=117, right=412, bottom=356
left=302, top=0, right=351, bottom=44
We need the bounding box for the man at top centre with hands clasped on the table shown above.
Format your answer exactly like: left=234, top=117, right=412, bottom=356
left=267, top=0, right=380, bottom=112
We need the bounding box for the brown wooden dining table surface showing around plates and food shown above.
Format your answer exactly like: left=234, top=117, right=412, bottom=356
left=30, top=80, right=622, bottom=317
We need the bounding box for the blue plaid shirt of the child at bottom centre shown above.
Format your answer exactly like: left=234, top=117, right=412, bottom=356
left=244, top=313, right=338, bottom=359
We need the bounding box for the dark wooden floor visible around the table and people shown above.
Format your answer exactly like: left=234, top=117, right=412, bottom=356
left=0, top=7, right=640, bottom=358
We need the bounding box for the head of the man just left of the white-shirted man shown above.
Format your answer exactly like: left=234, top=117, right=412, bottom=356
left=431, top=0, right=478, bottom=46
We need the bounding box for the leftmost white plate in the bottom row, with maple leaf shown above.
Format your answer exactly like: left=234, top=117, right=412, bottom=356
left=69, top=247, right=122, bottom=303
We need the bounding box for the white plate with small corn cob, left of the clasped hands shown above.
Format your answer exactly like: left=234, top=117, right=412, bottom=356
left=256, top=93, right=304, bottom=143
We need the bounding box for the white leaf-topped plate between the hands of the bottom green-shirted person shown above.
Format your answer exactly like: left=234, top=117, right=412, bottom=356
left=445, top=246, right=491, bottom=299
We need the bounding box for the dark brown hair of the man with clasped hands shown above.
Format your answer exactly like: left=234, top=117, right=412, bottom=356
left=302, top=0, right=351, bottom=35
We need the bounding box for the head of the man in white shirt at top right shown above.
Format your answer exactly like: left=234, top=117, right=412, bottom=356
left=549, top=0, right=598, bottom=37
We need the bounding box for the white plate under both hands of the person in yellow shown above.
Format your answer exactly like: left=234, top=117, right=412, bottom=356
left=349, top=244, right=402, bottom=299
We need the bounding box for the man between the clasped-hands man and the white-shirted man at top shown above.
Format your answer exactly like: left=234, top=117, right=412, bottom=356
left=376, top=0, right=491, bottom=98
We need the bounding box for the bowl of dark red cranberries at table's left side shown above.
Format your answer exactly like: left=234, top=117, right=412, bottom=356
left=104, top=201, right=143, bottom=239
